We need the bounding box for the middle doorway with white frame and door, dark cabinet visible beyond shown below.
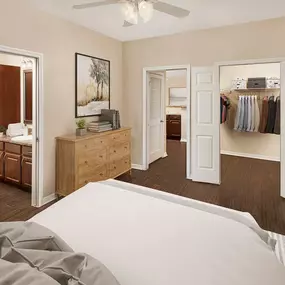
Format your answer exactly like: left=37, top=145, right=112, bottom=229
left=143, top=65, right=190, bottom=179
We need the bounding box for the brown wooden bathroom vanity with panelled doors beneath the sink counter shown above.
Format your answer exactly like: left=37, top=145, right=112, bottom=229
left=0, top=136, right=32, bottom=190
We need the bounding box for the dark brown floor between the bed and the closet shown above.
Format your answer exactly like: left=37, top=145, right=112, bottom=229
left=117, top=141, right=285, bottom=235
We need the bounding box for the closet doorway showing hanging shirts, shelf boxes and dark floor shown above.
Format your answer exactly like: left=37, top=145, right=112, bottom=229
left=218, top=60, right=285, bottom=199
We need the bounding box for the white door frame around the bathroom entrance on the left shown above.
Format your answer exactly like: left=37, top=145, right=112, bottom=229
left=0, top=45, right=44, bottom=207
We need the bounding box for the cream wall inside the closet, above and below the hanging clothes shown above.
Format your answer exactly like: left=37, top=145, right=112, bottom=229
left=220, top=63, right=280, bottom=160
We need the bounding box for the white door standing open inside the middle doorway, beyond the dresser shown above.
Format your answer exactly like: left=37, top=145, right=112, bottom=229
left=147, top=73, right=165, bottom=164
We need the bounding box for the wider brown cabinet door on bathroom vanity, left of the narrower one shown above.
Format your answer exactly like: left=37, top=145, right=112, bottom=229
left=4, top=153, right=21, bottom=184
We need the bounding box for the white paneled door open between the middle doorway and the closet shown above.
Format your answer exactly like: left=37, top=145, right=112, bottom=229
left=191, top=67, right=221, bottom=184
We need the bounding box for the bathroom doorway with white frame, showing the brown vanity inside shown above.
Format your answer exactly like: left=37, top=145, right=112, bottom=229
left=0, top=46, right=43, bottom=207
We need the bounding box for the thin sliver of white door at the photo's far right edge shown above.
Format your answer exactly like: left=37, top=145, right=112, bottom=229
left=280, top=62, right=285, bottom=198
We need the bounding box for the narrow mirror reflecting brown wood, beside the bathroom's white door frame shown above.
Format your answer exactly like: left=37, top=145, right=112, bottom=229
left=23, top=70, right=33, bottom=124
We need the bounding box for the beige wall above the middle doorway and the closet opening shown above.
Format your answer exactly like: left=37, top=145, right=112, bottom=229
left=123, top=18, right=285, bottom=164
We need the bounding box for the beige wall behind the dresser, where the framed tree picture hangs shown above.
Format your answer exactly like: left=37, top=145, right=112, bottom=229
left=0, top=0, right=124, bottom=199
